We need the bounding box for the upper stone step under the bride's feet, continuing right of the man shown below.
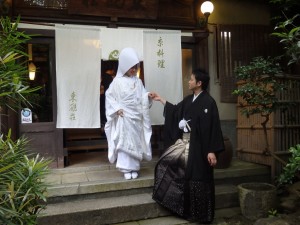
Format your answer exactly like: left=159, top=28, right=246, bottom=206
left=47, top=160, right=270, bottom=198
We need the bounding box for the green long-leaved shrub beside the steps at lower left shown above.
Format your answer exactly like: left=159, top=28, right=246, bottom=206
left=0, top=133, right=51, bottom=225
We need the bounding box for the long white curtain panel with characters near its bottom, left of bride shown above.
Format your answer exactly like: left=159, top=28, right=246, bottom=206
left=55, top=24, right=101, bottom=128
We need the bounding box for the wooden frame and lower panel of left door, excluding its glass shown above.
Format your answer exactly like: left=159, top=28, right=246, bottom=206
left=18, top=29, right=64, bottom=168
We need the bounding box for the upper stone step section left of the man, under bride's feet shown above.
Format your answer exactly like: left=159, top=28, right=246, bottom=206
left=47, top=163, right=154, bottom=200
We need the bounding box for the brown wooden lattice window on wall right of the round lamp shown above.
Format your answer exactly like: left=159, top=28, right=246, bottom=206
left=217, top=25, right=280, bottom=103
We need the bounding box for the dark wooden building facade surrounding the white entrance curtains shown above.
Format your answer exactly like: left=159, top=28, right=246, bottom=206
left=0, top=0, right=299, bottom=176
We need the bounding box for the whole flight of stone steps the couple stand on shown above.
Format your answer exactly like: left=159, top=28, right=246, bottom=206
left=38, top=159, right=270, bottom=225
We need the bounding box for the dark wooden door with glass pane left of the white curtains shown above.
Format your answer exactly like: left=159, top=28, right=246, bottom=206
left=18, top=35, right=64, bottom=168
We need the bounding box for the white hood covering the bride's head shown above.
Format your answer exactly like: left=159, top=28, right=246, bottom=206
left=116, top=48, right=139, bottom=77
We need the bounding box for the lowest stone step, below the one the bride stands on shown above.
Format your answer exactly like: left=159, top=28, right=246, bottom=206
left=38, top=185, right=238, bottom=225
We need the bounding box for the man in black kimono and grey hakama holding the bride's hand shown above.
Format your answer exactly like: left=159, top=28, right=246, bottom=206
left=151, top=70, right=224, bottom=223
